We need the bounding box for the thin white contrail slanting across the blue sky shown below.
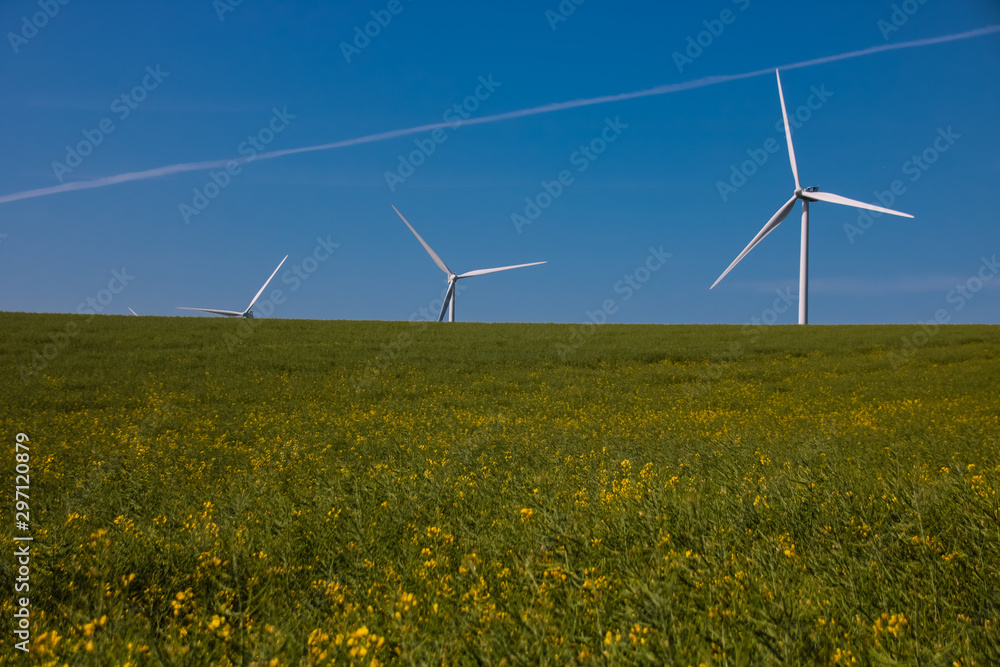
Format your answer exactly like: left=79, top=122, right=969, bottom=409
left=0, top=25, right=1000, bottom=204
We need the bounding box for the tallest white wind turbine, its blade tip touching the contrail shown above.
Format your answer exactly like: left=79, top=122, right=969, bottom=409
left=709, top=70, right=913, bottom=324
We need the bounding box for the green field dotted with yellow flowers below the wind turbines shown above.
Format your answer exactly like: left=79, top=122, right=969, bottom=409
left=0, top=313, right=1000, bottom=665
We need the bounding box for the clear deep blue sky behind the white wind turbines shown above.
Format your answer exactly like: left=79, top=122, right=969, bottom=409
left=0, top=0, right=1000, bottom=323
